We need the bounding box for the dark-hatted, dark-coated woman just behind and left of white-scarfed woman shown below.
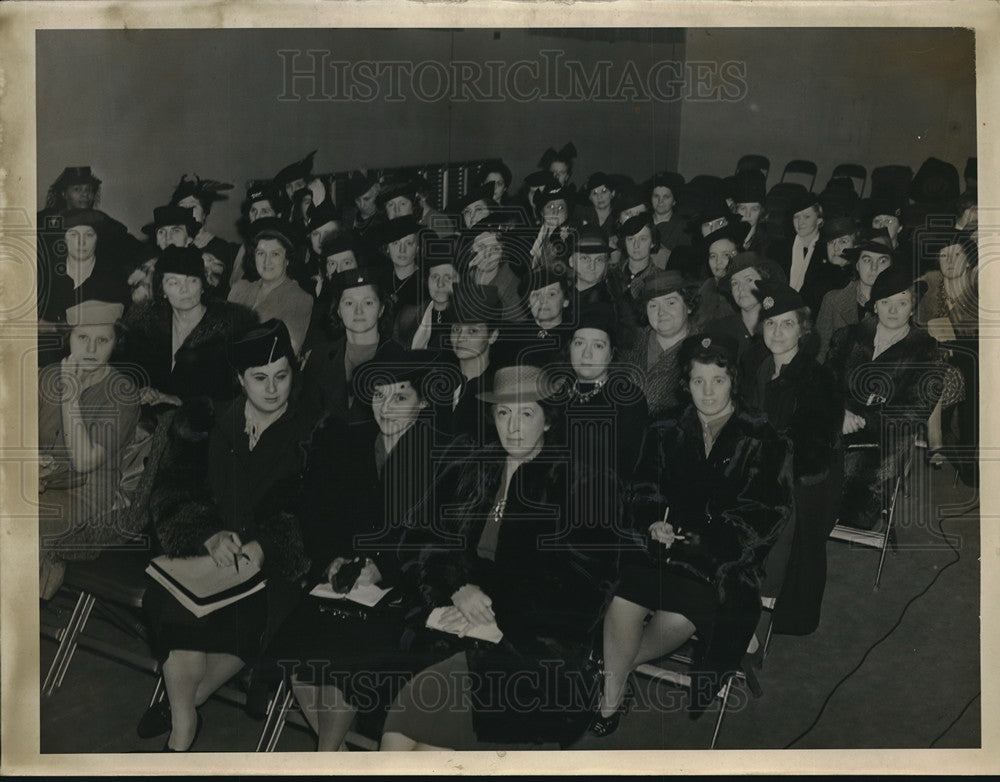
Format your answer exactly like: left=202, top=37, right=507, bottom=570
left=379, top=215, right=426, bottom=345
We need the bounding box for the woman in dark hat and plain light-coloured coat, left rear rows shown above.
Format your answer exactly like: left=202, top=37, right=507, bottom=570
left=229, top=218, right=313, bottom=353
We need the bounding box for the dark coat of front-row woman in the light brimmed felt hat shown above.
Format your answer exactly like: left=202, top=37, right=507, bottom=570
left=411, top=445, right=625, bottom=743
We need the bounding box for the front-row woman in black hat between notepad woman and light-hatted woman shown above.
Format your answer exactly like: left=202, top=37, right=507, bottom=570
left=271, top=340, right=450, bottom=751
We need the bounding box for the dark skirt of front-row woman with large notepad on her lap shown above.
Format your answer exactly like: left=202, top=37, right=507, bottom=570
left=142, top=578, right=269, bottom=662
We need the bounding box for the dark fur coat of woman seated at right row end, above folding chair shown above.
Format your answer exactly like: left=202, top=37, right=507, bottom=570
left=826, top=318, right=945, bottom=529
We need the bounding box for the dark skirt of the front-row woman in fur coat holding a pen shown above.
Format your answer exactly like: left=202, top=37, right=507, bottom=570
left=615, top=563, right=719, bottom=642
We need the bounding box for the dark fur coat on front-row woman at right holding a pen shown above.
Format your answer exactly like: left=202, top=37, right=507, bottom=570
left=623, top=405, right=792, bottom=695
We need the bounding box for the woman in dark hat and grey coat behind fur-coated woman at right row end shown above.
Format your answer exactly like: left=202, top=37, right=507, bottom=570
left=816, top=229, right=893, bottom=362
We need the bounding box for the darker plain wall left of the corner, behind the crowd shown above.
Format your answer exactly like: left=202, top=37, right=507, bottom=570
left=37, top=29, right=683, bottom=238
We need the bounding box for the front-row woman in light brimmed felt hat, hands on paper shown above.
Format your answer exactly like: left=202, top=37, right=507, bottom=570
left=382, top=366, right=618, bottom=750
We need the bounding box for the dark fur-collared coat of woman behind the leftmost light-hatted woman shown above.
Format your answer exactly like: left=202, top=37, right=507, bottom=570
left=125, top=299, right=257, bottom=402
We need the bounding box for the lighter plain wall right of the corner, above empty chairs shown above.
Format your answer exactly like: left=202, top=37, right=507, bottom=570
left=679, top=28, right=976, bottom=192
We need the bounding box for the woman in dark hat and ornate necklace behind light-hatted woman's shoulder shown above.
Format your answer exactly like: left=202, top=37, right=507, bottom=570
left=566, top=304, right=649, bottom=481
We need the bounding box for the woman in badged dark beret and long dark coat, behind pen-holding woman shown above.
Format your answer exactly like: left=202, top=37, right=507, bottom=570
left=744, top=280, right=844, bottom=635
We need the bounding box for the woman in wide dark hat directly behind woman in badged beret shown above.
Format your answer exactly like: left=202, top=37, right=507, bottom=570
left=705, top=252, right=785, bottom=374
